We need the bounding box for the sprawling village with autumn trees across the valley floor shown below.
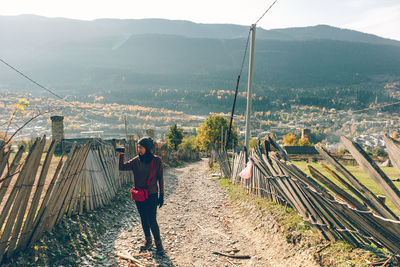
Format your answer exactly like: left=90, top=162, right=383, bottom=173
left=0, top=93, right=400, bottom=153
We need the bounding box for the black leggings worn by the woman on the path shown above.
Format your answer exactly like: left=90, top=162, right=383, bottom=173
left=136, top=194, right=161, bottom=241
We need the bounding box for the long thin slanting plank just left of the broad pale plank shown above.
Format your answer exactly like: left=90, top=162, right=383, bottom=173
left=315, top=145, right=397, bottom=219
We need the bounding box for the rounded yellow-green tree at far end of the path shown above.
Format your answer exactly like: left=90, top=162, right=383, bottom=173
left=197, top=115, right=239, bottom=151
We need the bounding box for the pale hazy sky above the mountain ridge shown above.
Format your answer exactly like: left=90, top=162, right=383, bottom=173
left=0, top=0, right=400, bottom=40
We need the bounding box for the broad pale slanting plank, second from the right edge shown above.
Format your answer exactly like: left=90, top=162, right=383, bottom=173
left=341, top=136, right=400, bottom=214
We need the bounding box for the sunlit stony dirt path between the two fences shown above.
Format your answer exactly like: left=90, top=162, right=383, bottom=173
left=78, top=160, right=317, bottom=266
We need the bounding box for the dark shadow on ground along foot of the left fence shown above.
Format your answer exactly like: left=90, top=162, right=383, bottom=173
left=0, top=169, right=179, bottom=266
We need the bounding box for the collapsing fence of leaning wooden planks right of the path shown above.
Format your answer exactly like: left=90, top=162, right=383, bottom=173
left=217, top=136, right=400, bottom=255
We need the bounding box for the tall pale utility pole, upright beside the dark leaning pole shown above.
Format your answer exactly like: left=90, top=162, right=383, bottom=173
left=245, top=24, right=257, bottom=151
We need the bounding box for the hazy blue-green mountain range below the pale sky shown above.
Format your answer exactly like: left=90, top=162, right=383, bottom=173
left=0, top=15, right=400, bottom=112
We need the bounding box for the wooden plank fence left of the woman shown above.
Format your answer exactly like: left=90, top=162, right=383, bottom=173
left=0, top=137, right=125, bottom=262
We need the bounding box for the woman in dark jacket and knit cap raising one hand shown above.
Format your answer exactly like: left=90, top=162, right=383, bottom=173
left=119, top=137, right=164, bottom=253
